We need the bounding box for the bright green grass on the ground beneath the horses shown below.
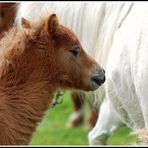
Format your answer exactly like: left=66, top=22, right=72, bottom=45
left=30, top=93, right=136, bottom=145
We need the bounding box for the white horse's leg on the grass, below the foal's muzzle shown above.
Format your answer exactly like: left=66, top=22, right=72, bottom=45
left=88, top=97, right=123, bottom=145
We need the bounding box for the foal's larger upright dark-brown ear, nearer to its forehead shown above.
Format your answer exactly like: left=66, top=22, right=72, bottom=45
left=45, top=14, right=59, bottom=34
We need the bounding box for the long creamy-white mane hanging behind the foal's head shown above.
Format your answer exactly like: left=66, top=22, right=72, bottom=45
left=16, top=2, right=132, bottom=67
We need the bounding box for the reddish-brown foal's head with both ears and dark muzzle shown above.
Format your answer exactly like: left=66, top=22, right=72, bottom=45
left=22, top=14, right=105, bottom=90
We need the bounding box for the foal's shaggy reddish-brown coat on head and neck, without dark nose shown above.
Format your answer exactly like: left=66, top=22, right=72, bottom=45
left=0, top=14, right=102, bottom=145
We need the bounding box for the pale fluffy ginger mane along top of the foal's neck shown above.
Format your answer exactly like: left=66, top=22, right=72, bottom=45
left=0, top=15, right=47, bottom=63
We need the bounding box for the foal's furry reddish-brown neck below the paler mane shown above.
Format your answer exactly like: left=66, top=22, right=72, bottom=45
left=0, top=30, right=56, bottom=144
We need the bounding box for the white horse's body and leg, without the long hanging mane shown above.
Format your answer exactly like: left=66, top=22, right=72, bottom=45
left=89, top=3, right=148, bottom=144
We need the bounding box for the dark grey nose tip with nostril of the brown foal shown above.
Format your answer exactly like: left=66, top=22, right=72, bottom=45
left=91, top=74, right=105, bottom=86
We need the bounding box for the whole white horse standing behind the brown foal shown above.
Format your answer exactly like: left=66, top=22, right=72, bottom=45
left=16, top=2, right=148, bottom=144
